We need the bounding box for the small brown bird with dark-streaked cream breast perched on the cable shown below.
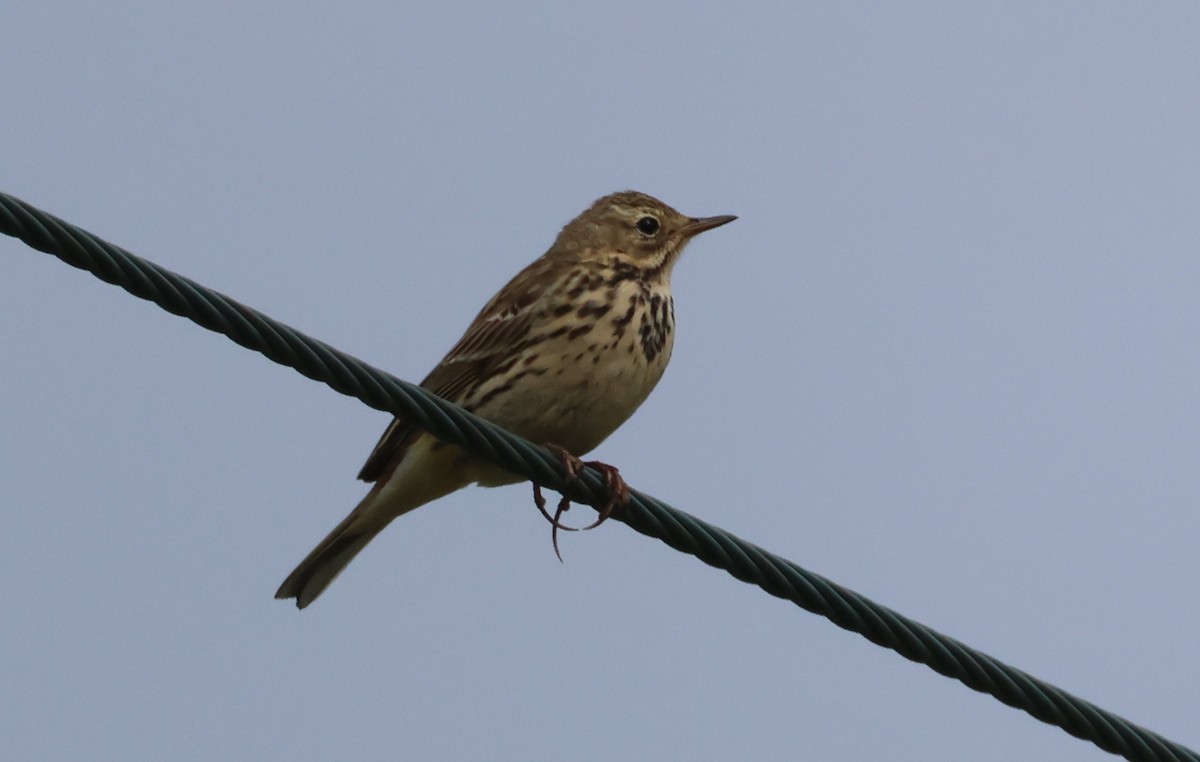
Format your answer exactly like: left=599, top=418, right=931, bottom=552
left=275, top=191, right=737, bottom=608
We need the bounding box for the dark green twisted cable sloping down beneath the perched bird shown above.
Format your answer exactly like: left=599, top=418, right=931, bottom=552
left=0, top=193, right=1200, bottom=762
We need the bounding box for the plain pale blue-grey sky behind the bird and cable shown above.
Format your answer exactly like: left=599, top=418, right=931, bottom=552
left=0, top=0, right=1200, bottom=761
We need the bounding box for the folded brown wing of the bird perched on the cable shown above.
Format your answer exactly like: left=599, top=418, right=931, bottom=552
left=359, top=263, right=544, bottom=481
